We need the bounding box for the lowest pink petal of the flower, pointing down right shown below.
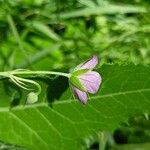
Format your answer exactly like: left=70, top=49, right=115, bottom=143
left=72, top=86, right=88, bottom=104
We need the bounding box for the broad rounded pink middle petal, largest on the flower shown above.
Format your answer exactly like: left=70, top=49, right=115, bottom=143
left=79, top=71, right=102, bottom=94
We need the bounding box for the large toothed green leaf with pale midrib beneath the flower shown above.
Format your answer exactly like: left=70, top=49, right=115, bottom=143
left=0, top=65, right=150, bottom=150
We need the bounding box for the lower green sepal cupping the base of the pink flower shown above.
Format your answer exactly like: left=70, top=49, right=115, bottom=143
left=69, top=74, right=86, bottom=92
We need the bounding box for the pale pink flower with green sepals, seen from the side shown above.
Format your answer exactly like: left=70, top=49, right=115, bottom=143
left=70, top=56, right=102, bottom=104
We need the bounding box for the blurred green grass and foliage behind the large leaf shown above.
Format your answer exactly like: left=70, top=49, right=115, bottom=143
left=0, top=0, right=150, bottom=150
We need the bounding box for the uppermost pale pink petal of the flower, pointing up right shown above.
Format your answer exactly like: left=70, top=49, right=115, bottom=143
left=75, top=55, right=98, bottom=70
